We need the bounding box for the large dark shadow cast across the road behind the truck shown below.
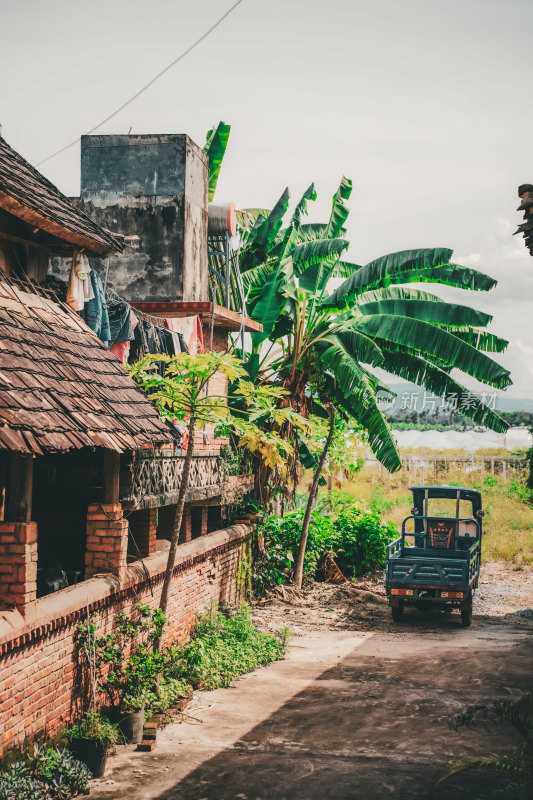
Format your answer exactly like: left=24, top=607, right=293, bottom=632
left=155, top=624, right=533, bottom=800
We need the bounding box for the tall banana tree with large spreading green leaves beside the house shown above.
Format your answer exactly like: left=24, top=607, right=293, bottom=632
left=240, top=178, right=511, bottom=568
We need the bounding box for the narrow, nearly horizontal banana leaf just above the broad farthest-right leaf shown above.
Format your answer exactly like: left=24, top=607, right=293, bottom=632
left=357, top=298, right=492, bottom=328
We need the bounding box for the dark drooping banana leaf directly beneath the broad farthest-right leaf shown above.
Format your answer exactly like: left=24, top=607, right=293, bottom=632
left=374, top=350, right=509, bottom=433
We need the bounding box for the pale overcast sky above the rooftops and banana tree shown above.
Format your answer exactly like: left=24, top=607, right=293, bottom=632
left=0, top=0, right=533, bottom=398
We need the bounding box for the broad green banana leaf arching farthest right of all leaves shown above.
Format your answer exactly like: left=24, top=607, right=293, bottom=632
left=354, top=314, right=511, bottom=388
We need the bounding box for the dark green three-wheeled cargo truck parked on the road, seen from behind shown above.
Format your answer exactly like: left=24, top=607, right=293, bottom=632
left=385, top=486, right=483, bottom=627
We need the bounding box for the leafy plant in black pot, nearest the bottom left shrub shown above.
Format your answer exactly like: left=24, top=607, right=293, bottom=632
left=65, top=711, right=120, bottom=778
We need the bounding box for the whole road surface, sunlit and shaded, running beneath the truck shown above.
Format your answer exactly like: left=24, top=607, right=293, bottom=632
left=91, top=570, right=533, bottom=800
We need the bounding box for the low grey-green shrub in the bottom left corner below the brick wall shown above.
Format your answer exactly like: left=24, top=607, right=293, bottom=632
left=0, top=746, right=92, bottom=800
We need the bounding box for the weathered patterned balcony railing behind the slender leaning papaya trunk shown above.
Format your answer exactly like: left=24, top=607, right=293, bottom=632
left=120, top=449, right=254, bottom=509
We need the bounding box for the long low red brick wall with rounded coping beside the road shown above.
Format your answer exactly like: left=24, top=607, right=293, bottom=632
left=0, top=520, right=251, bottom=753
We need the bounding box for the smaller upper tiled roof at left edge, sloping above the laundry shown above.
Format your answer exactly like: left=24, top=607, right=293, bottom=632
left=0, top=136, right=122, bottom=255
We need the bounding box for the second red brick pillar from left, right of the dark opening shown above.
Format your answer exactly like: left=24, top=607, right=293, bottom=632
left=85, top=503, right=128, bottom=582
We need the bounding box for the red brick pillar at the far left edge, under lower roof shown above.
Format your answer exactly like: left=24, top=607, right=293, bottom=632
left=0, top=522, right=37, bottom=613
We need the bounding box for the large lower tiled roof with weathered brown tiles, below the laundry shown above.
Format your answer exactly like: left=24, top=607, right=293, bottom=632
left=0, top=280, right=175, bottom=454
